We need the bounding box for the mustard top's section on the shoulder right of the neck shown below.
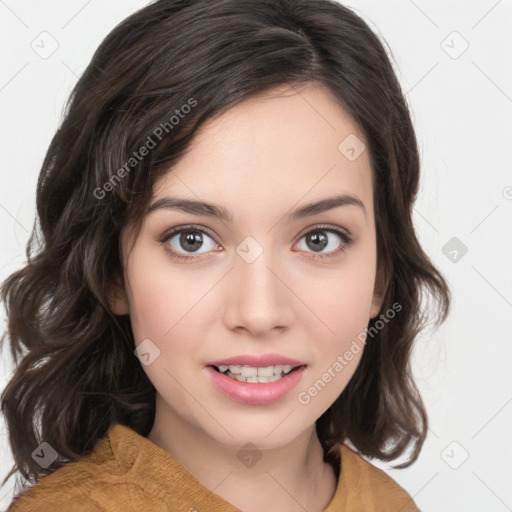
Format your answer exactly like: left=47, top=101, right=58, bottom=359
left=339, top=445, right=419, bottom=512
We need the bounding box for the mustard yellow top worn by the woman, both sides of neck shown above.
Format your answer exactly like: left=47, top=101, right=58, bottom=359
left=7, top=424, right=419, bottom=512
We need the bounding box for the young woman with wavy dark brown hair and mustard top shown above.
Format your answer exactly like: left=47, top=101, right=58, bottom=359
left=2, top=0, right=449, bottom=512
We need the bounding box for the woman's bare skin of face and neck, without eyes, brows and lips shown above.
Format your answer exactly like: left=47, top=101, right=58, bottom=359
left=112, top=83, right=383, bottom=512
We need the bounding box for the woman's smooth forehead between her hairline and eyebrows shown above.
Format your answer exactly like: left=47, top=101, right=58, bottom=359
left=153, top=84, right=373, bottom=222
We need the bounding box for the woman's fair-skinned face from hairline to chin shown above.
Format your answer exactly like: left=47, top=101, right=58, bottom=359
left=113, top=86, right=381, bottom=448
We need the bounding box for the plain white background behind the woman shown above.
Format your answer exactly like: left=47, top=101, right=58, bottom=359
left=0, top=0, right=512, bottom=512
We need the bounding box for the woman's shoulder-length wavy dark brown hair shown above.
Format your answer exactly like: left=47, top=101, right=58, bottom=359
left=1, top=0, right=450, bottom=496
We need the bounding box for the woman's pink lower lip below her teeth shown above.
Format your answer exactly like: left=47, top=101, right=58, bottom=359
left=206, top=366, right=306, bottom=404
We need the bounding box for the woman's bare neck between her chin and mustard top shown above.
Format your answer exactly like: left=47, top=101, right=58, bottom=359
left=147, top=394, right=337, bottom=512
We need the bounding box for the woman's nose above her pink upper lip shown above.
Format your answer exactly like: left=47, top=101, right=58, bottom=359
left=224, top=246, right=296, bottom=337
